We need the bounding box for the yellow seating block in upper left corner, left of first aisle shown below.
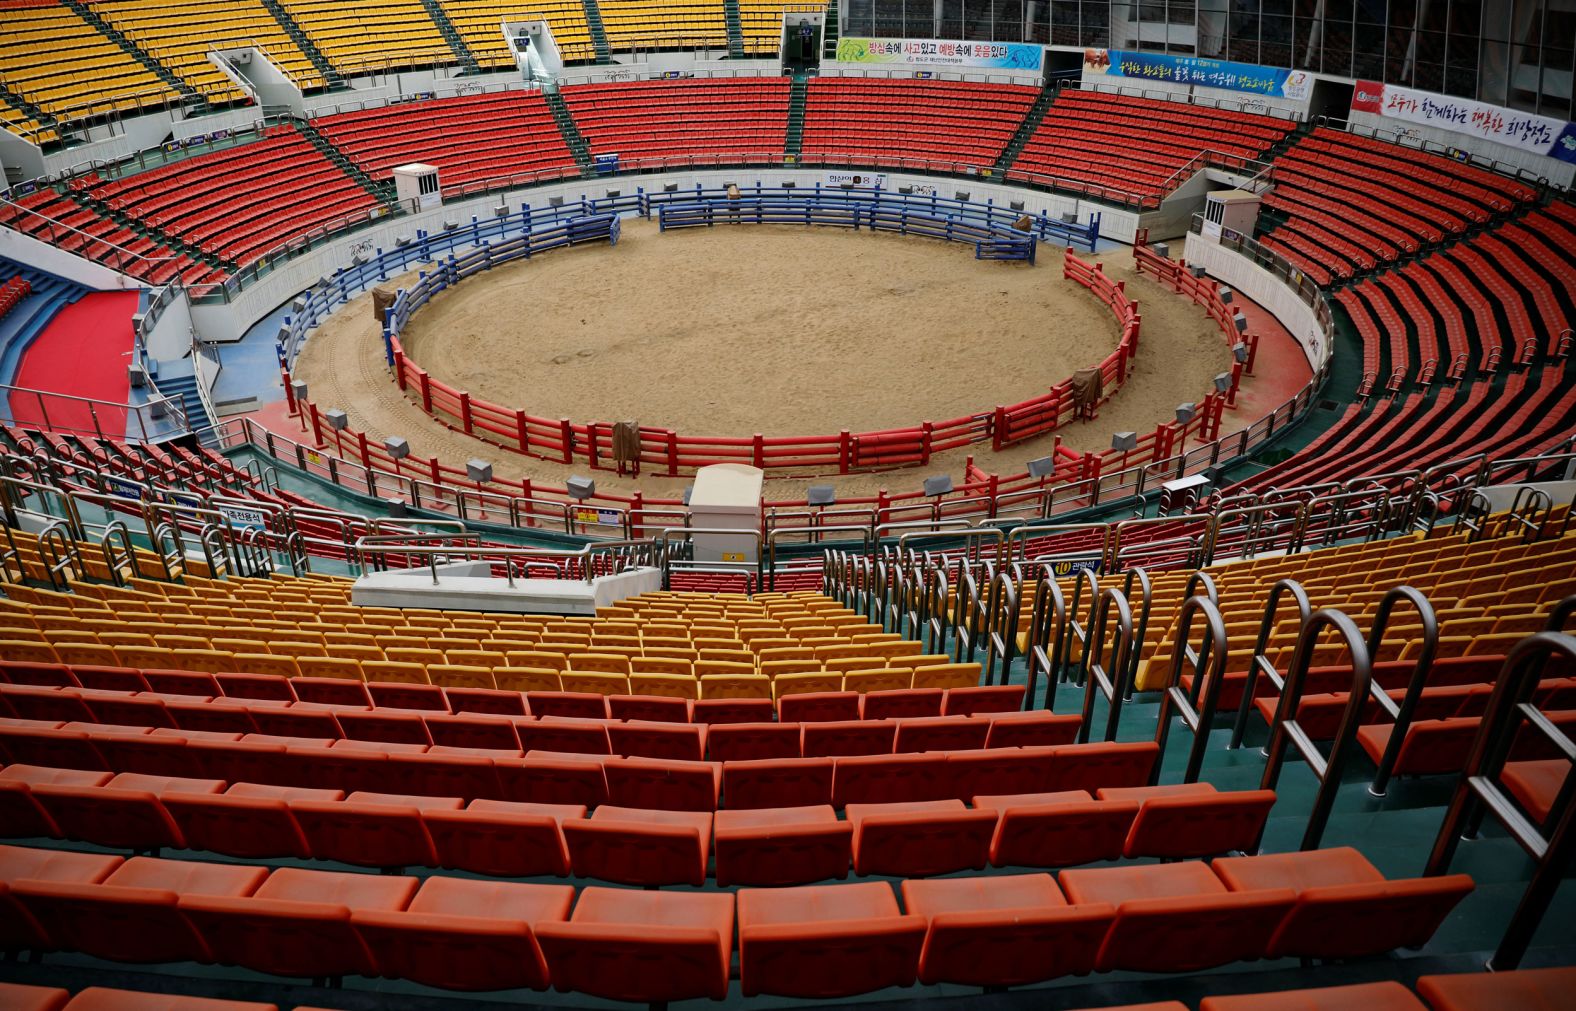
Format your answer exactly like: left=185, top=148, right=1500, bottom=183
left=0, top=2, right=177, bottom=123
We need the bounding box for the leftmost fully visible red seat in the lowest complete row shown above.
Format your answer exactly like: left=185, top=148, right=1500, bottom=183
left=11, top=856, right=268, bottom=962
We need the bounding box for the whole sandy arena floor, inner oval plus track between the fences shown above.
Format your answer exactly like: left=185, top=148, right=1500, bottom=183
left=296, top=221, right=1229, bottom=497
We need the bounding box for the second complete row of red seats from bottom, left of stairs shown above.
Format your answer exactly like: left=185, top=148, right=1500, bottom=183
left=0, top=765, right=1275, bottom=888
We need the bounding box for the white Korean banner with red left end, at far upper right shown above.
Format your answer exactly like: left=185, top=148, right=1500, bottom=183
left=1352, top=80, right=1576, bottom=162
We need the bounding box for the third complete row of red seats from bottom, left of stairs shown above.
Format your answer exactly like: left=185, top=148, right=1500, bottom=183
left=0, top=718, right=1157, bottom=812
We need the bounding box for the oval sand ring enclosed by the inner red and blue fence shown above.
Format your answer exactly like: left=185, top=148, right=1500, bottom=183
left=402, top=221, right=1121, bottom=437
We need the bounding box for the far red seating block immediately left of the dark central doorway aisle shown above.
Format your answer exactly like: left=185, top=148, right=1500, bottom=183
left=563, top=76, right=788, bottom=164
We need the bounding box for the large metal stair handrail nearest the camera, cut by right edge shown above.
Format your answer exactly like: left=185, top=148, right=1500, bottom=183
left=1423, top=627, right=1576, bottom=972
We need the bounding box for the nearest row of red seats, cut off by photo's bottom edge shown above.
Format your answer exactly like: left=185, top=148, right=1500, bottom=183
left=12, top=965, right=1576, bottom=1011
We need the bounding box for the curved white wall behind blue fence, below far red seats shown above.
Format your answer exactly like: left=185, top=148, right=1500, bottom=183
left=192, top=167, right=1138, bottom=342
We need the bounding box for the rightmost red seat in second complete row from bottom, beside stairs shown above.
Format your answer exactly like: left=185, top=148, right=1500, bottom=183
left=1097, top=782, right=1275, bottom=860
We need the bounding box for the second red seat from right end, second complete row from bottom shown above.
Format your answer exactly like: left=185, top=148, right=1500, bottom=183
left=974, top=790, right=1138, bottom=867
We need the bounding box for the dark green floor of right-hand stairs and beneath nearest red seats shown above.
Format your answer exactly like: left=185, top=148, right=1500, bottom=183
left=0, top=630, right=1576, bottom=1011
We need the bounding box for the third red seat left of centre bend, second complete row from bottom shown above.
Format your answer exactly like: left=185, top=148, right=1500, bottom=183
left=290, top=793, right=463, bottom=867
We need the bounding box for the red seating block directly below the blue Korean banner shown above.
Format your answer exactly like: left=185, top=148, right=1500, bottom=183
left=1007, top=88, right=1295, bottom=203
